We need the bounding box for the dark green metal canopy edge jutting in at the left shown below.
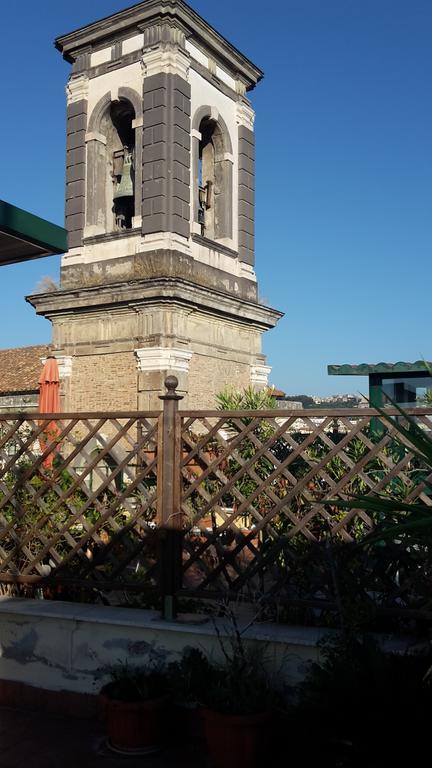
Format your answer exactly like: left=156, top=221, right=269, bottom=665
left=0, top=200, right=67, bottom=266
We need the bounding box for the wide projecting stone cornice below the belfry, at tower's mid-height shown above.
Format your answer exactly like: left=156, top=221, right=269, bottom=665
left=26, top=277, right=283, bottom=330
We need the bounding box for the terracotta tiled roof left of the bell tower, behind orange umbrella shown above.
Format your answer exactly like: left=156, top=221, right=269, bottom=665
left=0, top=344, right=49, bottom=395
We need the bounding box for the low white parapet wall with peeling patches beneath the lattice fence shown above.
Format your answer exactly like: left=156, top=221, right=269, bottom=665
left=0, top=598, right=325, bottom=694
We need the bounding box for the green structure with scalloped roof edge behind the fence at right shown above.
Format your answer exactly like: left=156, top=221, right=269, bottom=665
left=327, top=360, right=432, bottom=407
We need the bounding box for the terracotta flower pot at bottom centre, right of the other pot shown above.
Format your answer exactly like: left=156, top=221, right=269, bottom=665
left=201, top=708, right=270, bottom=768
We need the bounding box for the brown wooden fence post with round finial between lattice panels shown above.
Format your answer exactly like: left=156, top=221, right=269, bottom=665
left=157, top=376, right=183, bottom=621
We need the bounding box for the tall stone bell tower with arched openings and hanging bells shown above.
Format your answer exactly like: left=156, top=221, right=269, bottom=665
left=29, top=0, right=281, bottom=411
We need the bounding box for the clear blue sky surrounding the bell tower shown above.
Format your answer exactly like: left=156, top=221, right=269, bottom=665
left=0, top=0, right=432, bottom=394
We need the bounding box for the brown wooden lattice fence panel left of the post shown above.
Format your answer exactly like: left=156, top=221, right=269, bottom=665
left=0, top=413, right=160, bottom=589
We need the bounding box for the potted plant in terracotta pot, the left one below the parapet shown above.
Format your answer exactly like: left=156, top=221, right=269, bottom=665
left=100, top=662, right=169, bottom=755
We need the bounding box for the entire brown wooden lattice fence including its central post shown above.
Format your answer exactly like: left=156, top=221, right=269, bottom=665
left=0, top=382, right=432, bottom=620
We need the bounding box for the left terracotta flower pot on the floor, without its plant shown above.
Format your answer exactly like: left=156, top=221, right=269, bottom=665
left=104, top=696, right=167, bottom=754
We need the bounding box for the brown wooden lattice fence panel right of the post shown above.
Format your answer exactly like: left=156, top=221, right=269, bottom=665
left=178, top=402, right=432, bottom=621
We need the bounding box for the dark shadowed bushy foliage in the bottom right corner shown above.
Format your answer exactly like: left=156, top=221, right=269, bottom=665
left=299, top=633, right=432, bottom=765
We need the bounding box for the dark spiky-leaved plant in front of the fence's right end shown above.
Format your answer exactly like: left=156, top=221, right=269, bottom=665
left=314, top=401, right=432, bottom=630
